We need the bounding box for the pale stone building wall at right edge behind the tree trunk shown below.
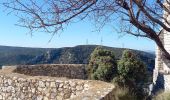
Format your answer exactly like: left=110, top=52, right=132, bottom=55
left=153, top=1, right=170, bottom=91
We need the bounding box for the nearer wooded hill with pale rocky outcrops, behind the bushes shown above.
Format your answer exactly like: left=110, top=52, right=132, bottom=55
left=27, top=45, right=155, bottom=70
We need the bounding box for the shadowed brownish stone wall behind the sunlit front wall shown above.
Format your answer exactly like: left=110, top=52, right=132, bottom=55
left=14, top=64, right=86, bottom=79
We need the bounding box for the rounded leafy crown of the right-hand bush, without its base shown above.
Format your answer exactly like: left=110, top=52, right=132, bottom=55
left=117, top=50, right=147, bottom=87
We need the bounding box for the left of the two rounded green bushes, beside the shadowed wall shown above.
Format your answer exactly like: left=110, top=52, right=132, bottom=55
left=88, top=47, right=116, bottom=82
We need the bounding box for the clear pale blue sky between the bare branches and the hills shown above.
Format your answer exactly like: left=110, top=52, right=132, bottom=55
left=0, top=7, right=155, bottom=51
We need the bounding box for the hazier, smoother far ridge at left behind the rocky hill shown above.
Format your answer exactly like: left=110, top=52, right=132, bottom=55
left=0, top=46, right=50, bottom=65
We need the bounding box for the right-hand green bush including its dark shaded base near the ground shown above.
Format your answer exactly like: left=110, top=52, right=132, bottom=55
left=113, top=50, right=147, bottom=100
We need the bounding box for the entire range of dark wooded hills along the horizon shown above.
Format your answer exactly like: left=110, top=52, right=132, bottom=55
left=0, top=45, right=155, bottom=70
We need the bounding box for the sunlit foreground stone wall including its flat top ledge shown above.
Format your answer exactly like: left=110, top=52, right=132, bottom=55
left=0, top=70, right=115, bottom=100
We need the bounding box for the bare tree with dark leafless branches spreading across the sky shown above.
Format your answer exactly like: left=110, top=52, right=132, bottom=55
left=3, top=0, right=170, bottom=60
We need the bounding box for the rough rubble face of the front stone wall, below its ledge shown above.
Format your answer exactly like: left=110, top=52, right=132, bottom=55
left=0, top=75, right=89, bottom=100
